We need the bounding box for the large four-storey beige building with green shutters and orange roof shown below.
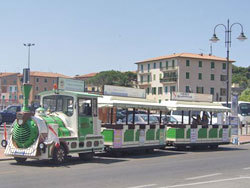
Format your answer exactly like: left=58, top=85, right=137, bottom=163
left=136, top=53, right=234, bottom=102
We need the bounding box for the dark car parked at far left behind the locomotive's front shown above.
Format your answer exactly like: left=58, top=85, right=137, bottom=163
left=0, top=105, right=21, bottom=125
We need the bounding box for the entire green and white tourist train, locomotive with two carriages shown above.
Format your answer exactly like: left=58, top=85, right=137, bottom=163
left=2, top=84, right=231, bottom=163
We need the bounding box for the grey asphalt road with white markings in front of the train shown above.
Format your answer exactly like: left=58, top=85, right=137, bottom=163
left=0, top=145, right=250, bottom=188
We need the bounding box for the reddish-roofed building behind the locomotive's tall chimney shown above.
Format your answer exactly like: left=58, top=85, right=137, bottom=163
left=17, top=71, right=71, bottom=106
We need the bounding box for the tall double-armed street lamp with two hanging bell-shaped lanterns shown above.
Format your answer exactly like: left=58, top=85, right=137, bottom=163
left=210, top=19, right=247, bottom=107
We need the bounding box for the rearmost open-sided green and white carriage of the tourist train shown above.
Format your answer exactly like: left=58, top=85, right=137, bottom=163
left=164, top=101, right=231, bottom=148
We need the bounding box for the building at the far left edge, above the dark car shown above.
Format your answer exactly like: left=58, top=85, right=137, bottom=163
left=0, top=72, right=19, bottom=110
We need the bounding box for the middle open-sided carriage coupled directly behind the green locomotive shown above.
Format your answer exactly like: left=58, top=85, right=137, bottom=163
left=98, top=96, right=167, bottom=151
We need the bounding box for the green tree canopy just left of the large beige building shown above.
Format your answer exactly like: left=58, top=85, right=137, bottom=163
left=87, top=70, right=137, bottom=87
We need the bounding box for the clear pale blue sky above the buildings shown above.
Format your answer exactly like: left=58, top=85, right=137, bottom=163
left=0, top=0, right=250, bottom=76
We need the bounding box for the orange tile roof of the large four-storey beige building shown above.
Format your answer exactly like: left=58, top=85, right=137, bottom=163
left=136, top=53, right=235, bottom=64
